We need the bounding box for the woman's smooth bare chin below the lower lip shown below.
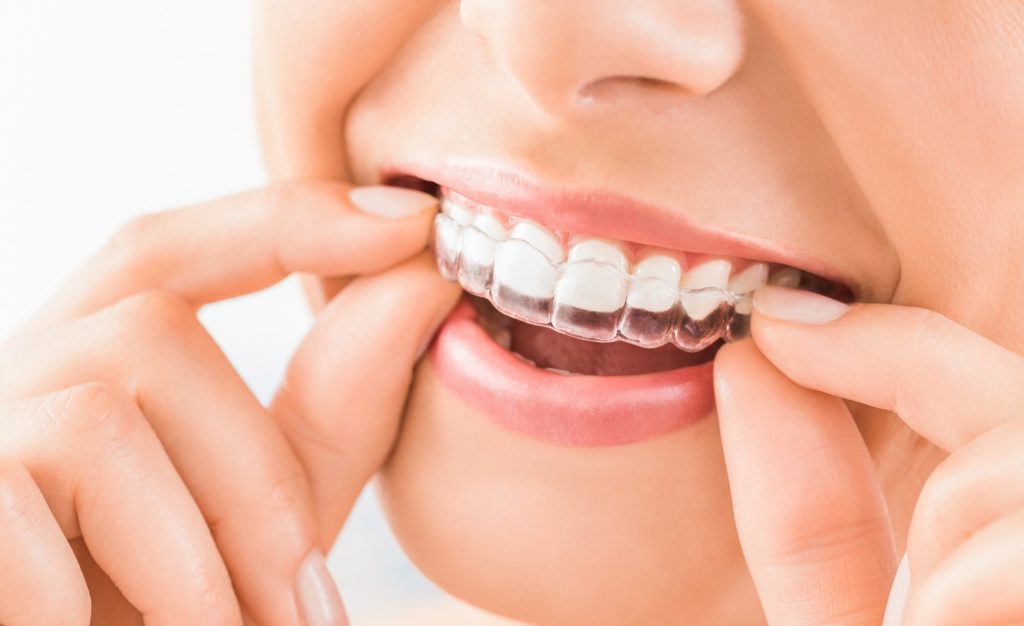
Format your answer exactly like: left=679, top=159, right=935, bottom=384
left=379, top=363, right=744, bottom=624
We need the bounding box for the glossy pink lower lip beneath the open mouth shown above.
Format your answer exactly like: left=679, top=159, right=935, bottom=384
left=430, top=298, right=715, bottom=446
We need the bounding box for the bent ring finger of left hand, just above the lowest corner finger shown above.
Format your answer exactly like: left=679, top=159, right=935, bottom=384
left=0, top=384, right=241, bottom=626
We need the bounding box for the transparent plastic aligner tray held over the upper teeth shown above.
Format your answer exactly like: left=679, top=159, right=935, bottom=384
left=433, top=213, right=751, bottom=352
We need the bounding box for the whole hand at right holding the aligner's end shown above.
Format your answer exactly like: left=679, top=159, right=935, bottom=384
left=715, top=288, right=1024, bottom=626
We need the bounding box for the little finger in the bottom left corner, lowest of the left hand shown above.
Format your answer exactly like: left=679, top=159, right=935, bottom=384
left=0, top=459, right=91, bottom=626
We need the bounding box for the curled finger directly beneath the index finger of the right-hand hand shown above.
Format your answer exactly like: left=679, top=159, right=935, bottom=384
left=907, top=419, right=1024, bottom=580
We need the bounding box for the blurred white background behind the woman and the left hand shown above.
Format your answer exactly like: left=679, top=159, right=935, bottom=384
left=0, top=0, right=507, bottom=626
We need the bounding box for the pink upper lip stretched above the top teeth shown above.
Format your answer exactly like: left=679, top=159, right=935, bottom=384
left=380, top=163, right=864, bottom=299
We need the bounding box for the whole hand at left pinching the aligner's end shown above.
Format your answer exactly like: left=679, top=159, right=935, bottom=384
left=0, top=182, right=458, bottom=626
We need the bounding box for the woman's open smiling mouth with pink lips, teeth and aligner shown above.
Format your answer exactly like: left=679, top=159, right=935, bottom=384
left=382, top=167, right=855, bottom=446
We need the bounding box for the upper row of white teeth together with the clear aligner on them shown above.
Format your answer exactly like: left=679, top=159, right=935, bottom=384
left=433, top=201, right=786, bottom=352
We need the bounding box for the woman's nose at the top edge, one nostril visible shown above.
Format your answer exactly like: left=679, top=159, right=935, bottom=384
left=460, top=0, right=745, bottom=115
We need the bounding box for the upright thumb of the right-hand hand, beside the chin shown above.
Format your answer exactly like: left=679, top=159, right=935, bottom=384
left=715, top=341, right=896, bottom=626
